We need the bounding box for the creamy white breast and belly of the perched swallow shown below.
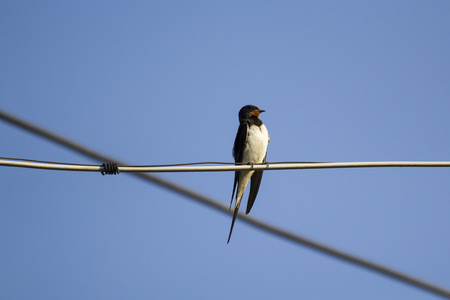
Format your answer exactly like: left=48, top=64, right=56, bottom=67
left=242, top=124, right=269, bottom=163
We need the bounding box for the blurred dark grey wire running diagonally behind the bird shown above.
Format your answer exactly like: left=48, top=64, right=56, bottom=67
left=0, top=110, right=450, bottom=299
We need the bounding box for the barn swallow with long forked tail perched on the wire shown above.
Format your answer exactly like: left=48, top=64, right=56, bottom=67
left=227, top=105, right=270, bottom=244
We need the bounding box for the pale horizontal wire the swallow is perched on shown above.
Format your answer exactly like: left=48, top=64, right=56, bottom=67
left=0, top=157, right=450, bottom=173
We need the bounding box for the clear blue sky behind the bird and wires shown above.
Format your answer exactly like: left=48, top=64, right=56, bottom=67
left=0, top=0, right=450, bottom=300
